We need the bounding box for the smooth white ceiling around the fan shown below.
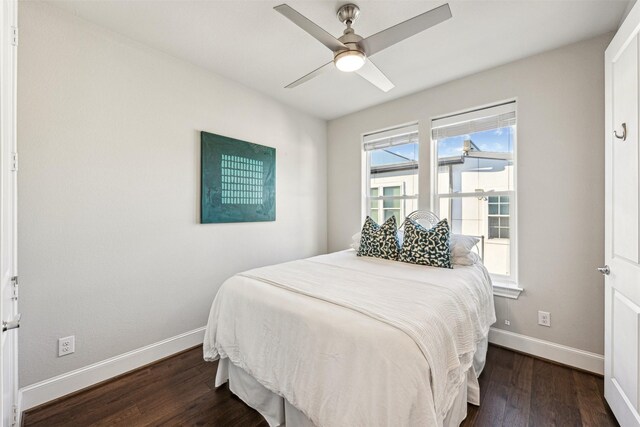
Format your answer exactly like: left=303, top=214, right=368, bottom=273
left=49, top=0, right=628, bottom=119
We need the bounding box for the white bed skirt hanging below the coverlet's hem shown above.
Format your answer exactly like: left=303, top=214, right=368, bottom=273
left=215, top=337, right=488, bottom=427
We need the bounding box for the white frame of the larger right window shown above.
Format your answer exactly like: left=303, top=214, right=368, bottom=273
left=429, top=98, right=522, bottom=286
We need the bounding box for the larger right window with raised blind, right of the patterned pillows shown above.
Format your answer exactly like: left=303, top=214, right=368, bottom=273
left=431, top=102, right=516, bottom=281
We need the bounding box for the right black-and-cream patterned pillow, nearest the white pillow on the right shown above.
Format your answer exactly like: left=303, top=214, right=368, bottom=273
left=399, top=218, right=453, bottom=268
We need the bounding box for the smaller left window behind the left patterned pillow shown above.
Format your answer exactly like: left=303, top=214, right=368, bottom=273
left=364, top=125, right=418, bottom=225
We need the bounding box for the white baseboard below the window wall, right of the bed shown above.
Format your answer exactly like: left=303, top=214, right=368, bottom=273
left=489, top=328, right=604, bottom=375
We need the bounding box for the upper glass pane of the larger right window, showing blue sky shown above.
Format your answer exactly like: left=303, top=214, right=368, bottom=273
left=436, top=126, right=515, bottom=194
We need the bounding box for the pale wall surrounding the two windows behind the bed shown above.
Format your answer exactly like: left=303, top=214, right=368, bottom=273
left=328, top=34, right=612, bottom=354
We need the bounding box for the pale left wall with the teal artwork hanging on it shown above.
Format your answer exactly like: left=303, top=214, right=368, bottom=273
left=18, top=2, right=326, bottom=386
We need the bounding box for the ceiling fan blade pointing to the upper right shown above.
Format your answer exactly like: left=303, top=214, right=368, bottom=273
left=360, top=4, right=452, bottom=56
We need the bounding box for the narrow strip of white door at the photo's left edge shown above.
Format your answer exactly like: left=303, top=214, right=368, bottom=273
left=0, top=0, right=19, bottom=426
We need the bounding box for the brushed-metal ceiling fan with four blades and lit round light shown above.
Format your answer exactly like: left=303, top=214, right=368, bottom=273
left=274, top=4, right=451, bottom=92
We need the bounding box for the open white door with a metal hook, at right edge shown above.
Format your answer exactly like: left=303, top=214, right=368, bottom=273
left=603, top=4, right=640, bottom=427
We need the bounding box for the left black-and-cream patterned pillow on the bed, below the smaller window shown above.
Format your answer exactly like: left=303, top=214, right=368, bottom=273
left=358, top=216, right=400, bottom=260
